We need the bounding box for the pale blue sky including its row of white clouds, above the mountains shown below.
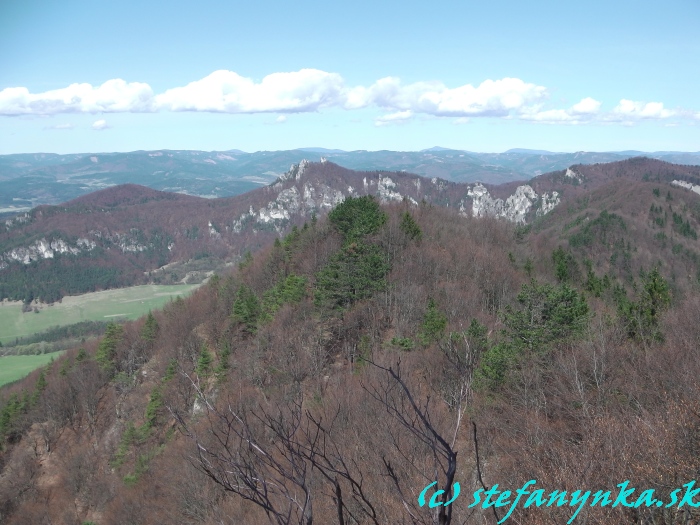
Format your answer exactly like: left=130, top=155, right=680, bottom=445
left=0, top=0, right=700, bottom=154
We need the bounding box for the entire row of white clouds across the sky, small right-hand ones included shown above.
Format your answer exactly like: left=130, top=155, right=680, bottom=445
left=0, top=69, right=700, bottom=129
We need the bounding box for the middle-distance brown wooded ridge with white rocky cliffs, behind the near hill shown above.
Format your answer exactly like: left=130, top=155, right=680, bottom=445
left=0, top=158, right=700, bottom=304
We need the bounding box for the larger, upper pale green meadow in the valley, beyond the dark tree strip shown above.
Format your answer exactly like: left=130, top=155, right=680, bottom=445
left=0, top=285, right=199, bottom=346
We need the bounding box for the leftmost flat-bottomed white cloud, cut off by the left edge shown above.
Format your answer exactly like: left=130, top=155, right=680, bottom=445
left=0, top=78, right=153, bottom=116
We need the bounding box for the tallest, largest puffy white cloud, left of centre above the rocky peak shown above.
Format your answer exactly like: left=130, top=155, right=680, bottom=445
left=156, top=69, right=343, bottom=113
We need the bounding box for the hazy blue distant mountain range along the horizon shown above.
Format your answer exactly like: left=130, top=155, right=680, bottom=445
left=0, top=146, right=700, bottom=216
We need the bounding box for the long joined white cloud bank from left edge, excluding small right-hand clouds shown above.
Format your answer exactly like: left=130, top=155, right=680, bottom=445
left=0, top=69, right=547, bottom=117
